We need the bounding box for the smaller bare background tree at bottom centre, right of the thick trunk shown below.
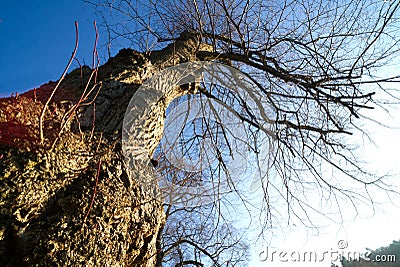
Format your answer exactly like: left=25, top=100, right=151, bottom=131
left=157, top=205, right=249, bottom=266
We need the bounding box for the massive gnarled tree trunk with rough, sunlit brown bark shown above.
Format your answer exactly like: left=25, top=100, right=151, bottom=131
left=0, top=30, right=211, bottom=266
